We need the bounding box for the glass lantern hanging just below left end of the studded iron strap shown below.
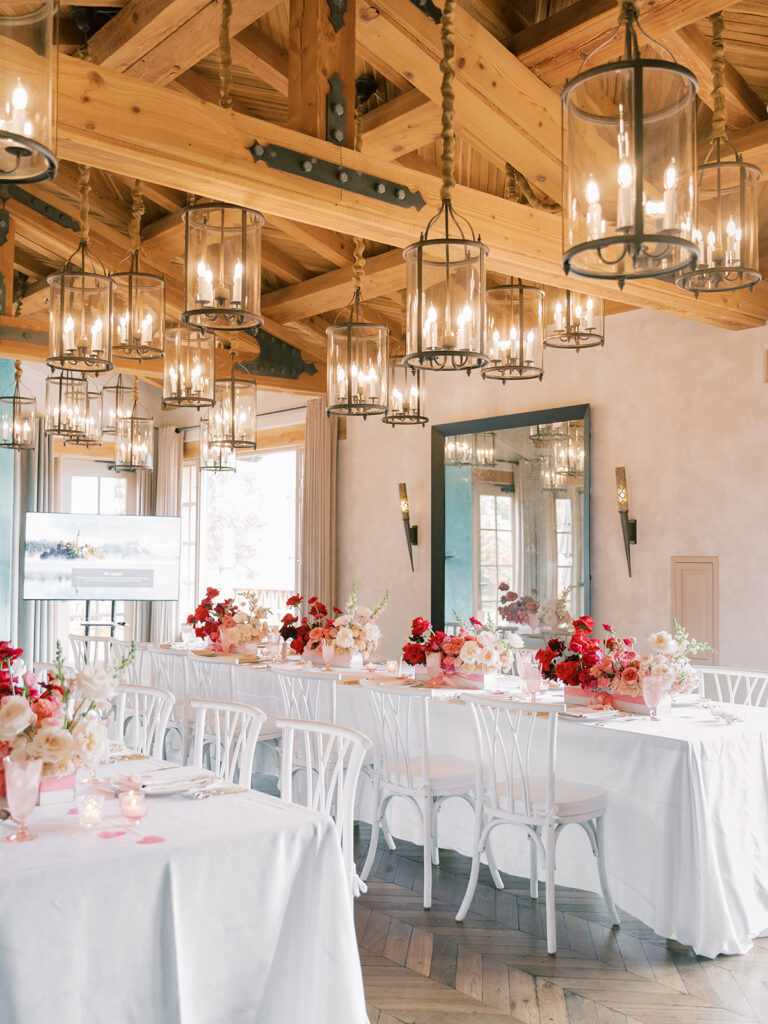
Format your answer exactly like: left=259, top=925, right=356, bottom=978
left=181, top=0, right=264, bottom=331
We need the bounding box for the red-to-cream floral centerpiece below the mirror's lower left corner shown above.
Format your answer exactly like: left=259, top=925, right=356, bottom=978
left=402, top=617, right=522, bottom=685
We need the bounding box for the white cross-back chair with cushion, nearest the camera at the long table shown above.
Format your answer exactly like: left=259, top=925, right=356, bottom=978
left=456, top=693, right=618, bottom=953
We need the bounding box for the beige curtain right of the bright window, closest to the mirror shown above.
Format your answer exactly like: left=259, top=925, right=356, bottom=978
left=299, top=398, right=339, bottom=606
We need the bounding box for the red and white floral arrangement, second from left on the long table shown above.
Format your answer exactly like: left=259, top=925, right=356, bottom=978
left=280, top=585, right=389, bottom=657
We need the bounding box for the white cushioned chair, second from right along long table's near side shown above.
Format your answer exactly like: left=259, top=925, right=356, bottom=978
left=360, top=679, right=483, bottom=908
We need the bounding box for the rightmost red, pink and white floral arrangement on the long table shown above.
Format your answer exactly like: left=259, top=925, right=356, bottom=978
left=536, top=615, right=713, bottom=699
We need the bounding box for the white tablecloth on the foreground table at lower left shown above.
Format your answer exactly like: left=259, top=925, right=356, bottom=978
left=0, top=762, right=368, bottom=1024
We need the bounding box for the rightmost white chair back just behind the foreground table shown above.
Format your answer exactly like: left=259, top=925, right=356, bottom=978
left=275, top=718, right=369, bottom=896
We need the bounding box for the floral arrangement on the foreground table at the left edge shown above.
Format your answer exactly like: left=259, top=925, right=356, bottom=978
left=0, top=641, right=135, bottom=793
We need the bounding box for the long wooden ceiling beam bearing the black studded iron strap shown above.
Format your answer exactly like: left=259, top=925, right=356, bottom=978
left=58, top=54, right=768, bottom=330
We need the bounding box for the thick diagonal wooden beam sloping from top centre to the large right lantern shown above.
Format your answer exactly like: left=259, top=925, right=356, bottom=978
left=357, top=0, right=562, bottom=202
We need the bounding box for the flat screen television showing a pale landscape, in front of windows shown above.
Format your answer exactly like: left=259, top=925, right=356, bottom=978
left=24, top=512, right=181, bottom=601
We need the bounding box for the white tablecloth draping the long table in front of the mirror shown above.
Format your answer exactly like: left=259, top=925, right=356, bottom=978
left=228, top=668, right=768, bottom=956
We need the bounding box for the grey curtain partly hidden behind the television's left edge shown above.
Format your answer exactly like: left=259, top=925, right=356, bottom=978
left=12, top=418, right=55, bottom=667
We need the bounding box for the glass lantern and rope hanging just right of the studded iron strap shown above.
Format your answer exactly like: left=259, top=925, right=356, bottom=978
left=403, top=0, right=488, bottom=373
